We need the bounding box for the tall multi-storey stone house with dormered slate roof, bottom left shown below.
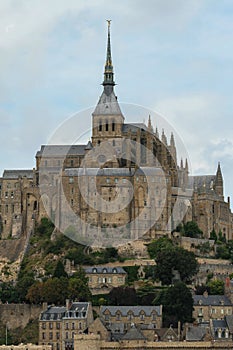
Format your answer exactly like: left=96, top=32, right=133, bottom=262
left=39, top=301, right=93, bottom=350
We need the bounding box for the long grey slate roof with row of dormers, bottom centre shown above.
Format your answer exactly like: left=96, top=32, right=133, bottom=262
left=100, top=305, right=161, bottom=316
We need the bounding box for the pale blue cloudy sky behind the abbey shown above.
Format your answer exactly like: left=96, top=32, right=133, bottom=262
left=0, top=0, right=233, bottom=205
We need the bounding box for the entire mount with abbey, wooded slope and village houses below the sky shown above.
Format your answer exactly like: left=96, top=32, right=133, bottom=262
left=0, top=2, right=233, bottom=350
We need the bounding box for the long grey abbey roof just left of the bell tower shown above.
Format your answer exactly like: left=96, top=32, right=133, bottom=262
left=36, top=143, right=87, bottom=157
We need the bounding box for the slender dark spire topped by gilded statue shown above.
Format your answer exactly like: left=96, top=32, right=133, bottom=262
left=103, top=20, right=115, bottom=95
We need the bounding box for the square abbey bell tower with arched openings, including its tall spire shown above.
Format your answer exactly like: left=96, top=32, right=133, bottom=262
left=92, top=20, right=124, bottom=146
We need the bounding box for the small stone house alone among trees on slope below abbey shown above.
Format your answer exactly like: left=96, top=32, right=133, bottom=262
left=84, top=266, right=127, bottom=294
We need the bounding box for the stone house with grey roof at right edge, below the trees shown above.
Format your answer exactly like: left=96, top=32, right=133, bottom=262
left=193, top=292, right=233, bottom=323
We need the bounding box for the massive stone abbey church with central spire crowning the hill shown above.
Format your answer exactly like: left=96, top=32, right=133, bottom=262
left=0, top=23, right=233, bottom=245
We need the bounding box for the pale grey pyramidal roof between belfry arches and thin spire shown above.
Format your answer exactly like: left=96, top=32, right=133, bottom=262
left=92, top=91, right=122, bottom=116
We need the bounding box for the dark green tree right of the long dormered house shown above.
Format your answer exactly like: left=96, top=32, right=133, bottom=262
left=154, top=282, right=193, bottom=327
